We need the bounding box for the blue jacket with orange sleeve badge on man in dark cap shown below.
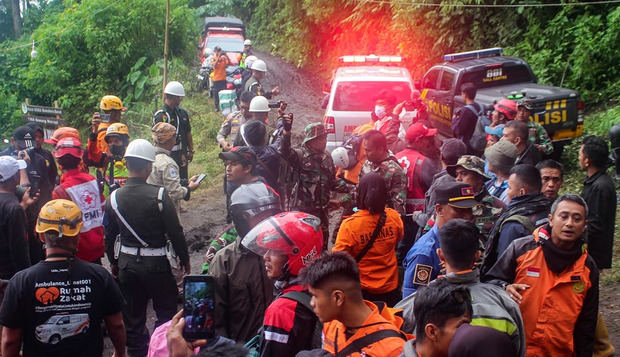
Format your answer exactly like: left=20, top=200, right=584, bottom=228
left=403, top=225, right=441, bottom=298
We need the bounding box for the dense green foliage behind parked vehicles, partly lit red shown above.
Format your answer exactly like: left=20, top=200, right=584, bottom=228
left=223, top=0, right=620, bottom=104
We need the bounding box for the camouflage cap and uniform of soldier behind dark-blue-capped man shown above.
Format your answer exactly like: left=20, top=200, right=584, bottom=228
left=447, top=155, right=506, bottom=243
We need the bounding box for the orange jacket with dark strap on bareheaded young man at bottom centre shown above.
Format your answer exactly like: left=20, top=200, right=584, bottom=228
left=323, top=301, right=410, bottom=357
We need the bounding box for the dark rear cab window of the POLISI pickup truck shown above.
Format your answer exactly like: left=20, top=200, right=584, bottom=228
left=461, top=65, right=534, bottom=89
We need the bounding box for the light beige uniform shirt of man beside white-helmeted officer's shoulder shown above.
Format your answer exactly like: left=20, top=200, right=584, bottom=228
left=146, top=147, right=190, bottom=212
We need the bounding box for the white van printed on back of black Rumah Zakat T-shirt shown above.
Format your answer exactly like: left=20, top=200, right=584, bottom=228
left=35, top=314, right=90, bottom=345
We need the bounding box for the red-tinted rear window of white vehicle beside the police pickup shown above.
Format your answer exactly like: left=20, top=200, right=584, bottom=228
left=333, top=81, right=411, bottom=112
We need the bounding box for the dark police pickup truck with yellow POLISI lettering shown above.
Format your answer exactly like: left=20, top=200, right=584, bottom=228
left=415, top=47, right=584, bottom=158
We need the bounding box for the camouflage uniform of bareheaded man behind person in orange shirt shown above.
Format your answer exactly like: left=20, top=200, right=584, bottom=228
left=360, top=154, right=407, bottom=216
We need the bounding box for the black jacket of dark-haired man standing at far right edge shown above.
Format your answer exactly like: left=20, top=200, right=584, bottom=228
left=581, top=170, right=616, bottom=269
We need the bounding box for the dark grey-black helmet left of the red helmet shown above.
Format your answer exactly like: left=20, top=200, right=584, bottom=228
left=230, top=181, right=282, bottom=238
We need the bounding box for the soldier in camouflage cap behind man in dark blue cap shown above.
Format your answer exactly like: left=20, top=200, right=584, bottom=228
left=446, top=155, right=506, bottom=243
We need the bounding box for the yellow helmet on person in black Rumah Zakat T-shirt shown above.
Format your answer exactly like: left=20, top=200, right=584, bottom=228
left=35, top=200, right=82, bottom=237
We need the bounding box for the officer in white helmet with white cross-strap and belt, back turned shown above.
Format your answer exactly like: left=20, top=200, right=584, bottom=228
left=104, top=139, right=190, bottom=357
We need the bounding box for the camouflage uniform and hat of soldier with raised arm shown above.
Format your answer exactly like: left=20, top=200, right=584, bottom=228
left=280, top=123, right=347, bottom=242
